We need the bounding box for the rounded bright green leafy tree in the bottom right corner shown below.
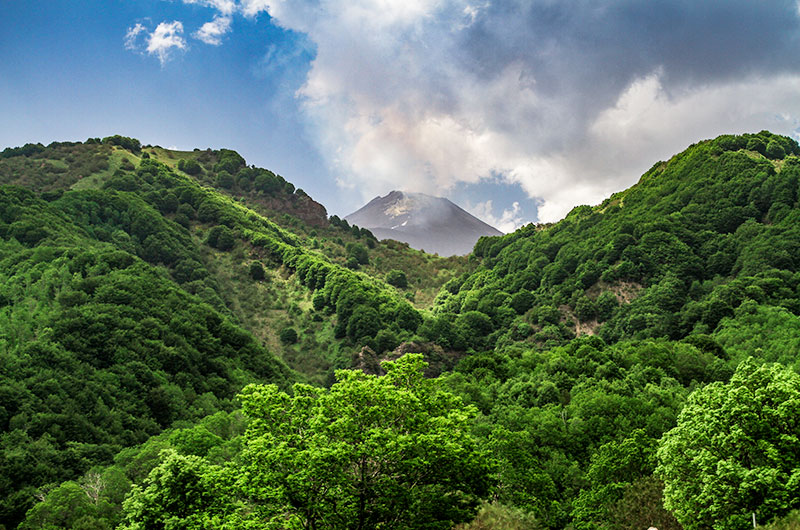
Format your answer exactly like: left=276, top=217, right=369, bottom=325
left=657, top=358, right=800, bottom=530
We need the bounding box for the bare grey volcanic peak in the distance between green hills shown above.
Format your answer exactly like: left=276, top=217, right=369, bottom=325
left=345, top=191, right=502, bottom=256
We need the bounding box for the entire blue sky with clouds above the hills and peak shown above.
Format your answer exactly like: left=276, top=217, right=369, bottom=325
left=0, top=0, right=800, bottom=230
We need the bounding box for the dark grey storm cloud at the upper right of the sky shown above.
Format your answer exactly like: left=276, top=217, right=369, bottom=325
left=454, top=0, right=800, bottom=134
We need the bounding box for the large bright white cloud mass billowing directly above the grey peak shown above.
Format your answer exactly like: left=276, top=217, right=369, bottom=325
left=252, top=0, right=800, bottom=221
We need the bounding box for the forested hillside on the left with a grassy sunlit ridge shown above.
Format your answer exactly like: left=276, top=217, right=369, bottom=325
left=0, top=136, right=449, bottom=526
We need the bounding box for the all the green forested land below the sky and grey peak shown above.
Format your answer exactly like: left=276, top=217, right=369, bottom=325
left=0, top=131, right=800, bottom=530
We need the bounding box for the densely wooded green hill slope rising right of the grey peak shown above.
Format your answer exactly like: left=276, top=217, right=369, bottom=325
left=434, top=131, right=800, bottom=348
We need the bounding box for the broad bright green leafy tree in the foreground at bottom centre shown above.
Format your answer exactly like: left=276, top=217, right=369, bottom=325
left=238, top=354, right=490, bottom=530
